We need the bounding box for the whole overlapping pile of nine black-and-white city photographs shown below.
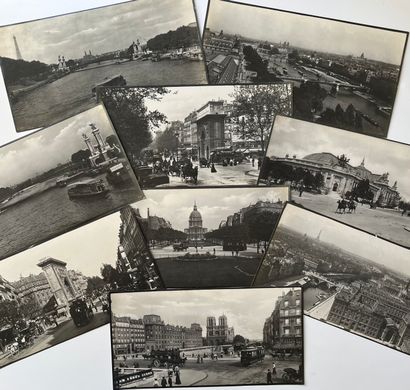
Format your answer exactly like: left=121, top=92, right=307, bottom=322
left=0, top=0, right=410, bottom=389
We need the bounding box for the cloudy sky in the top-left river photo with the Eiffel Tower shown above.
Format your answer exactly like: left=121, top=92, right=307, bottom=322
left=0, top=0, right=195, bottom=64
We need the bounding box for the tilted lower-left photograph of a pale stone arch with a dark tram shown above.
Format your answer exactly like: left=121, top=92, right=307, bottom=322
left=0, top=212, right=163, bottom=367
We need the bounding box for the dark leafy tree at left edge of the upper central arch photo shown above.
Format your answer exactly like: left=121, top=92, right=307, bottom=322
left=99, top=87, right=170, bottom=164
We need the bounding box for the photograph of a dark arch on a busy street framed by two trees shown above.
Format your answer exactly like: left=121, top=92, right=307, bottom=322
left=98, top=84, right=292, bottom=189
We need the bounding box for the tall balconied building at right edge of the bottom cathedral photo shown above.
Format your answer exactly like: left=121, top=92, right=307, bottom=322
left=263, top=289, right=303, bottom=354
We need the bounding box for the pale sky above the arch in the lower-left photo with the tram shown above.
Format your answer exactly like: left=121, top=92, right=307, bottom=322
left=0, top=212, right=121, bottom=282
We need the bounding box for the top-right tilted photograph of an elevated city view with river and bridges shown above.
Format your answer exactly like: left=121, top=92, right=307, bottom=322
left=203, top=0, right=408, bottom=137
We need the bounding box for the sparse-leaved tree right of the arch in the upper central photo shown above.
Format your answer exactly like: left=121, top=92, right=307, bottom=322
left=232, top=84, right=292, bottom=153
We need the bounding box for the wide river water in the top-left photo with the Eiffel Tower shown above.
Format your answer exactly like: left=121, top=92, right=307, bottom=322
left=12, top=60, right=207, bottom=131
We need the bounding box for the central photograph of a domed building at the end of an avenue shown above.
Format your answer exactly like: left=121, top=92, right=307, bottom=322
left=128, top=187, right=289, bottom=288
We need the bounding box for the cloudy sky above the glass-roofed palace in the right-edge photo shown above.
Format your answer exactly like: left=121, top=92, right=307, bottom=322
left=267, top=116, right=410, bottom=200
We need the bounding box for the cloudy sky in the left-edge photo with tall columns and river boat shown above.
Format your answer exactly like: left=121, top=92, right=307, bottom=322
left=0, top=106, right=113, bottom=187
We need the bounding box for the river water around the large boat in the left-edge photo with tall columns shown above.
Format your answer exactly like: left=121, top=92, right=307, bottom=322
left=0, top=174, right=140, bottom=259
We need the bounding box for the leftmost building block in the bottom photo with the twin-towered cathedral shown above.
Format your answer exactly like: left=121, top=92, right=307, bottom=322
left=111, top=316, right=145, bottom=355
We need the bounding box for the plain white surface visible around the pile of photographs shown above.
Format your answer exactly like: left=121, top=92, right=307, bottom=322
left=0, top=0, right=410, bottom=390
